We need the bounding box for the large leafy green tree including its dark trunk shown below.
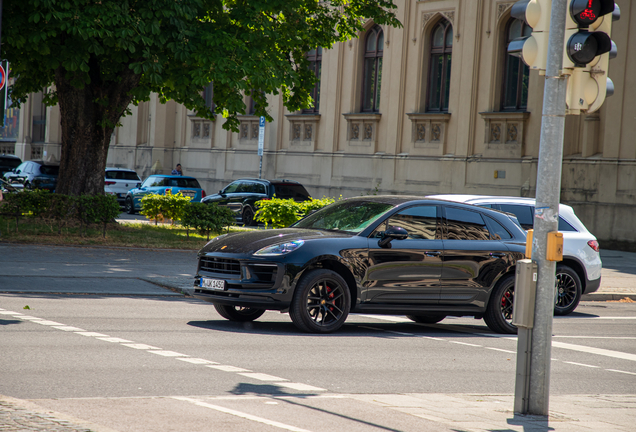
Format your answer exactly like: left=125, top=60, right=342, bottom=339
left=2, top=0, right=400, bottom=195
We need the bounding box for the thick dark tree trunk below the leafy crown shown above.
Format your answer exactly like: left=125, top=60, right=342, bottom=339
left=55, top=61, right=140, bottom=195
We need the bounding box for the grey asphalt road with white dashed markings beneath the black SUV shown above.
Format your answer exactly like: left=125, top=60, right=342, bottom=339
left=0, top=245, right=636, bottom=432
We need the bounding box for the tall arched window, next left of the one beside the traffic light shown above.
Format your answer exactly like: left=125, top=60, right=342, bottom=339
left=427, top=19, right=453, bottom=112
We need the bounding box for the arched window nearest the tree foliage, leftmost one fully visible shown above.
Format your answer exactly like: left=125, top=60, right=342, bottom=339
left=362, top=26, right=384, bottom=112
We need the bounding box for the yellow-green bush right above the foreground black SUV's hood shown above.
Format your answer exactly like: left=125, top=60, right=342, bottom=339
left=255, top=197, right=335, bottom=228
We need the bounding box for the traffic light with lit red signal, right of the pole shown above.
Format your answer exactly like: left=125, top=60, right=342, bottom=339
left=563, top=0, right=620, bottom=114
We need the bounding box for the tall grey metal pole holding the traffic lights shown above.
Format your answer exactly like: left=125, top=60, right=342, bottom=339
left=527, top=0, right=568, bottom=415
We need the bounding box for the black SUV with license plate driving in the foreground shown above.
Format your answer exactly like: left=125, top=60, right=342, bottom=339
left=187, top=196, right=526, bottom=333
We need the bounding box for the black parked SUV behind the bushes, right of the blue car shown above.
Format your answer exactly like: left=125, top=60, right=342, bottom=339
left=201, top=179, right=311, bottom=226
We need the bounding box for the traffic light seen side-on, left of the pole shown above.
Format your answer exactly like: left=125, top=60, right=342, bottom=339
left=508, top=0, right=552, bottom=72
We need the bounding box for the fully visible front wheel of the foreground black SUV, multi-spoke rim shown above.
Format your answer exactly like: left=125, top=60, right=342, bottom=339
left=289, top=269, right=351, bottom=333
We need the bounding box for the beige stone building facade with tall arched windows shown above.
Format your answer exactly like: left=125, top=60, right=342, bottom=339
left=2, top=0, right=636, bottom=247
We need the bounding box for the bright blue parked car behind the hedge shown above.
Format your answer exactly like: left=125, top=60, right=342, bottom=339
left=125, top=175, right=205, bottom=214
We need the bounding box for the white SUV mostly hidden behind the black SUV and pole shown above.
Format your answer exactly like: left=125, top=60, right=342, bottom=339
left=428, top=194, right=603, bottom=315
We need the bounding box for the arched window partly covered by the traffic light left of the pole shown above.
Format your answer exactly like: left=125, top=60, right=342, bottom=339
left=501, top=18, right=532, bottom=111
